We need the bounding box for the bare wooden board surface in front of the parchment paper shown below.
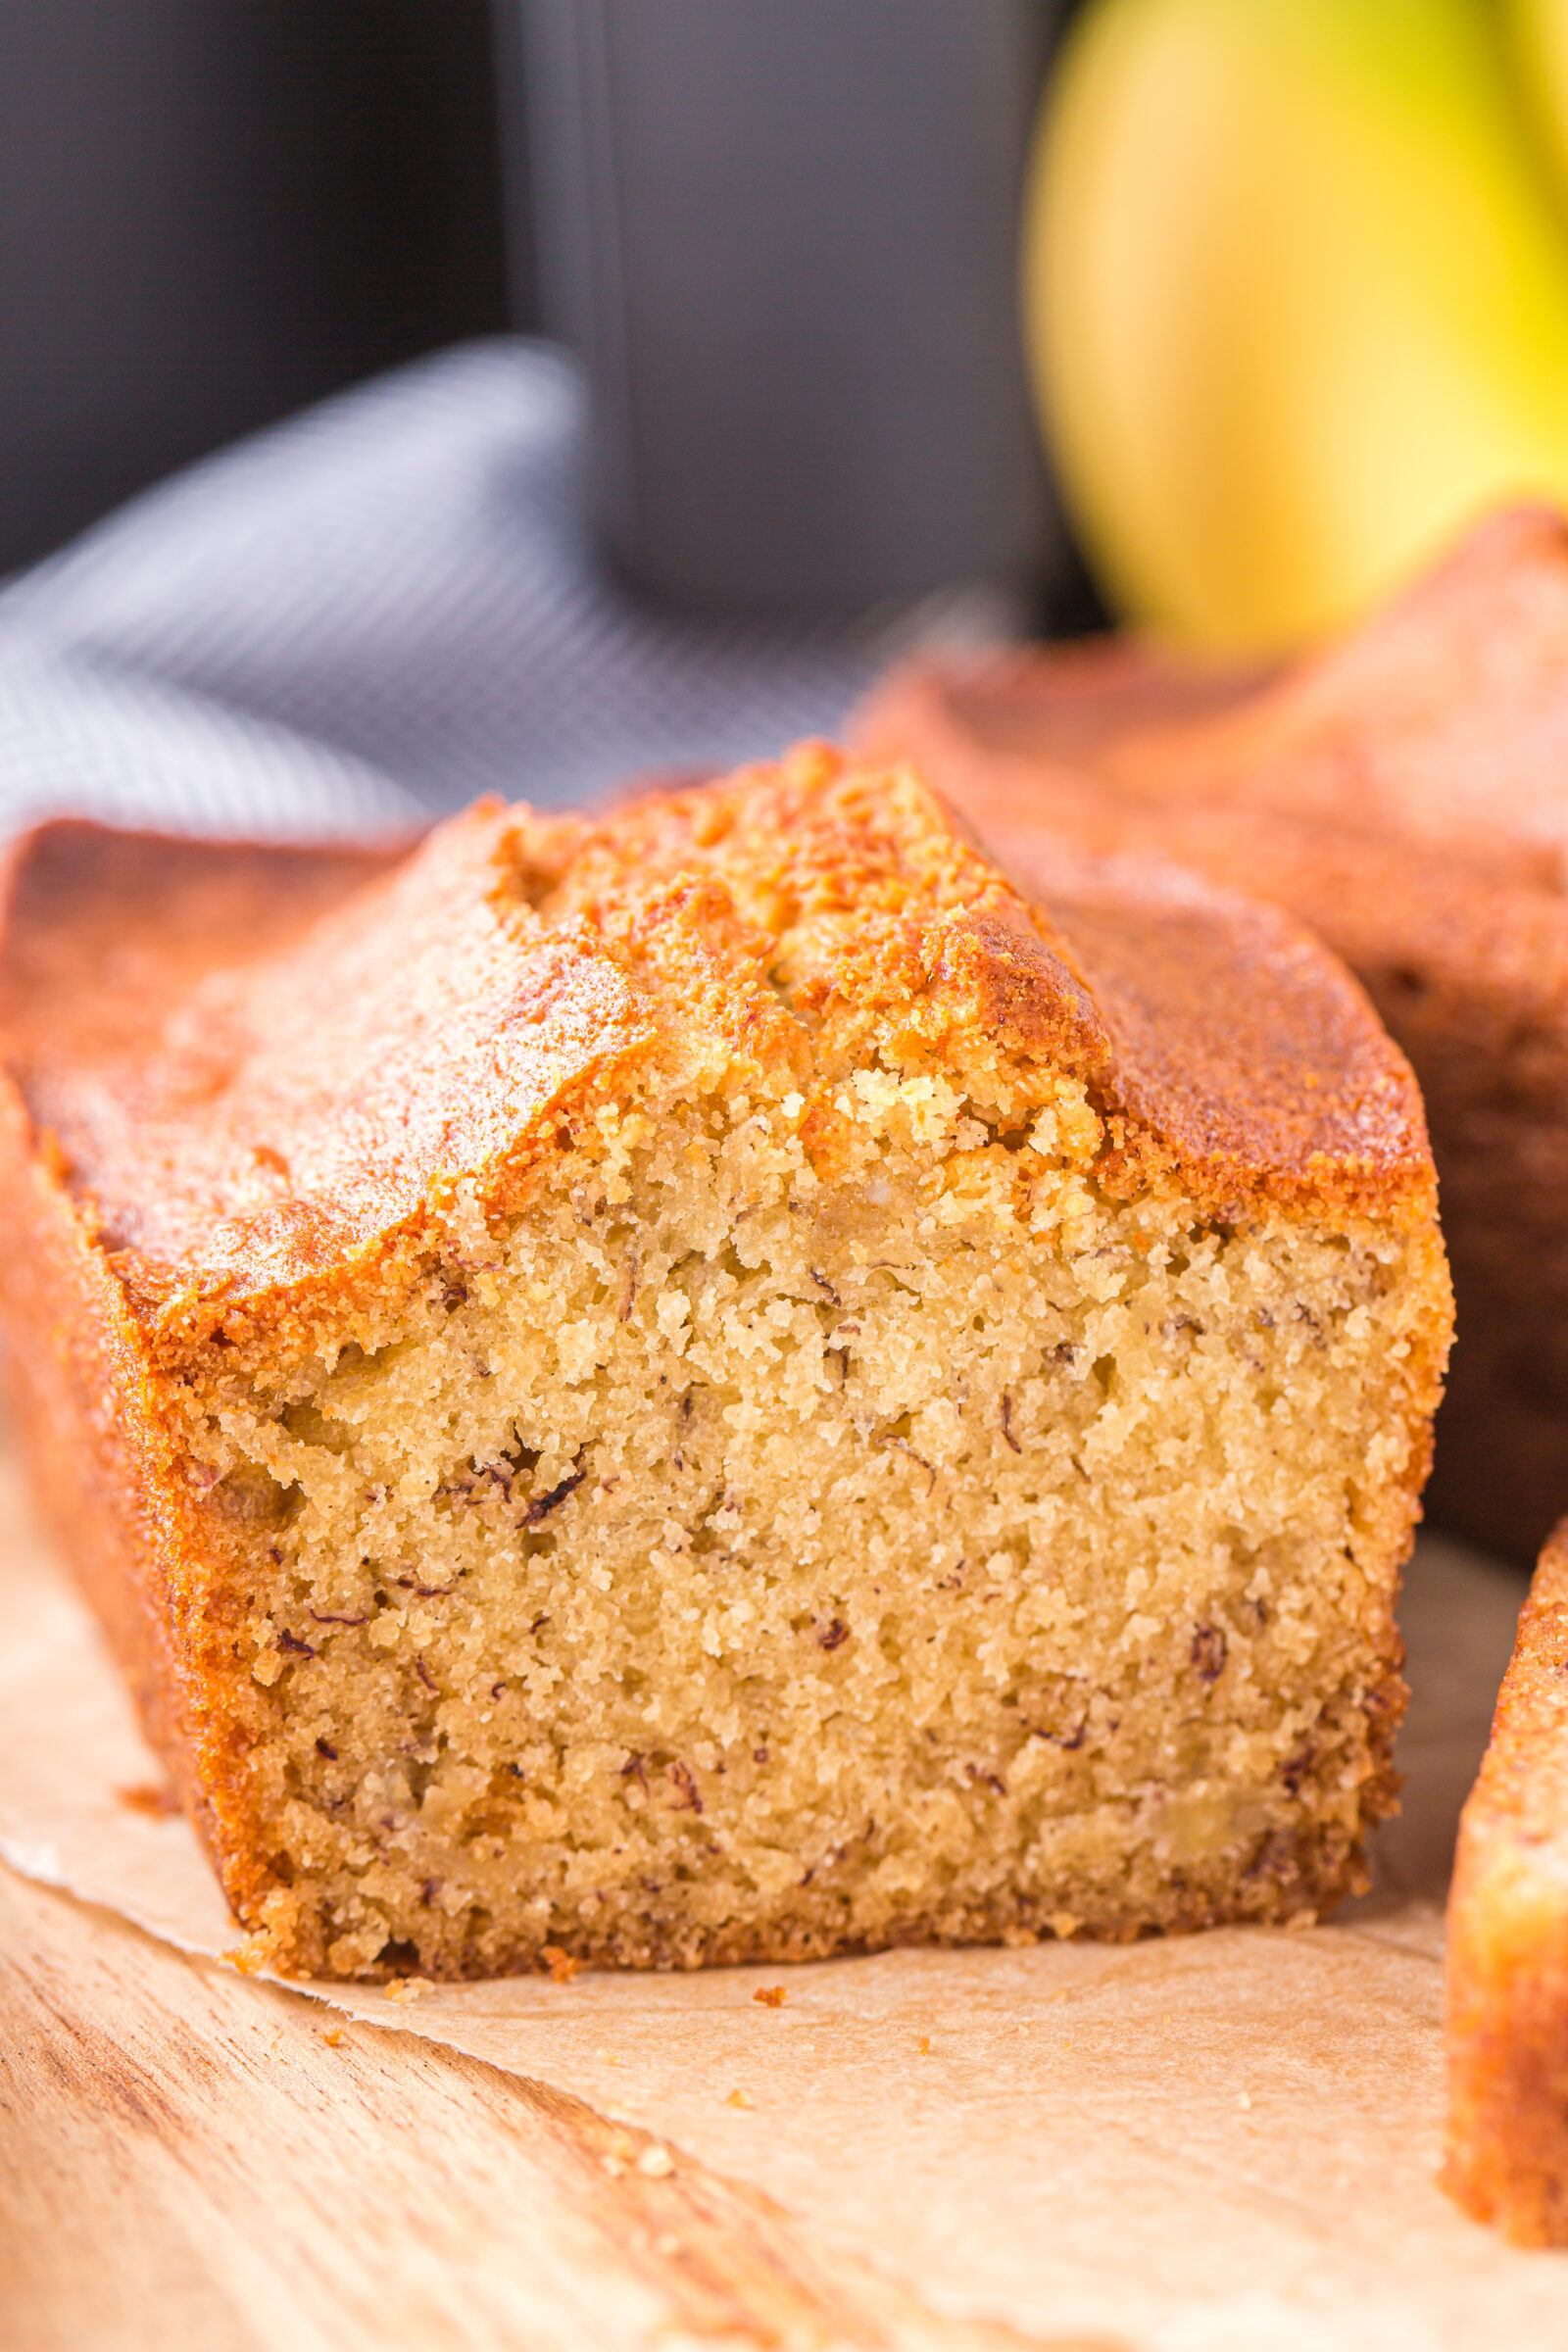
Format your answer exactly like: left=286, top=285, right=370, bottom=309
left=0, top=1868, right=1109, bottom=2352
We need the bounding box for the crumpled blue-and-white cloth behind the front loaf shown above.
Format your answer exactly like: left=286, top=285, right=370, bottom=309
left=0, top=341, right=1013, bottom=835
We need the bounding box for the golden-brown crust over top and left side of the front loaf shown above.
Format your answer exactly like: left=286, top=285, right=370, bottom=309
left=0, top=748, right=1444, bottom=1957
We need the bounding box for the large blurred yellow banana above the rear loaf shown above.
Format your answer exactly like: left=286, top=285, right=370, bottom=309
left=1022, top=0, right=1568, bottom=652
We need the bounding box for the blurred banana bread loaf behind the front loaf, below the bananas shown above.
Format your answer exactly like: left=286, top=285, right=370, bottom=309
left=856, top=511, right=1568, bottom=1562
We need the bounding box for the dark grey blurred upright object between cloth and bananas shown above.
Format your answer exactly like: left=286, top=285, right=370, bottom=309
left=514, top=0, right=1057, bottom=612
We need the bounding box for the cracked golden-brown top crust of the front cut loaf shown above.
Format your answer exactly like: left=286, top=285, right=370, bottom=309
left=0, top=746, right=1432, bottom=1343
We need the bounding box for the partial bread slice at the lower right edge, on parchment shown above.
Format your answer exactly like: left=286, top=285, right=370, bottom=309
left=1444, top=1519, right=1568, bottom=2246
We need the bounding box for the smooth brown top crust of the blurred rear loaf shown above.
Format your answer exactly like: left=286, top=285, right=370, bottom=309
left=883, top=508, right=1568, bottom=892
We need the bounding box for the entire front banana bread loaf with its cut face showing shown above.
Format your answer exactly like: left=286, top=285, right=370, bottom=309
left=0, top=748, right=1448, bottom=1976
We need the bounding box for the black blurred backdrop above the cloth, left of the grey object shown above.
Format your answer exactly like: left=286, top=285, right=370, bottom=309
left=0, top=0, right=521, bottom=571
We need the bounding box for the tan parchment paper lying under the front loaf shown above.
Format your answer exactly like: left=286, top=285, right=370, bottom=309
left=0, top=1463, right=1568, bottom=2352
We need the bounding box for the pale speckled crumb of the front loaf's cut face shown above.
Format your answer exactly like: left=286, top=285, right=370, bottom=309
left=193, top=1070, right=1408, bottom=1976
